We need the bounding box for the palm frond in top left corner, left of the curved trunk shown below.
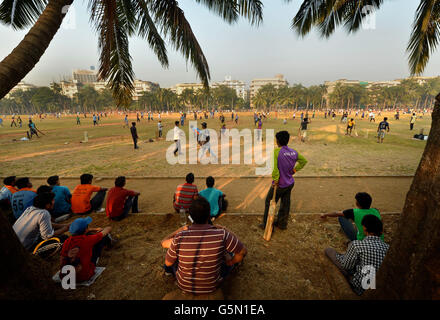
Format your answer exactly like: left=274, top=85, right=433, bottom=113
left=0, top=0, right=48, bottom=30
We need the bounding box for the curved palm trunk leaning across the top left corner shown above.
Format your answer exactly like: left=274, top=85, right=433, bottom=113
left=0, top=0, right=74, bottom=99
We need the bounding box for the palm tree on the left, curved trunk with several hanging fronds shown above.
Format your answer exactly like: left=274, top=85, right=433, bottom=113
left=0, top=0, right=263, bottom=106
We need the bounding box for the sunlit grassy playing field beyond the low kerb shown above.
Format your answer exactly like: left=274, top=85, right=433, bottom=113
left=0, top=113, right=431, bottom=177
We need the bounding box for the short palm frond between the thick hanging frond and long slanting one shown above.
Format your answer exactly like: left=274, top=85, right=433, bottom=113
left=137, top=0, right=169, bottom=67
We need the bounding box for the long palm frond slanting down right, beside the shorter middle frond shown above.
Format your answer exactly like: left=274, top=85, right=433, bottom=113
left=149, top=0, right=210, bottom=87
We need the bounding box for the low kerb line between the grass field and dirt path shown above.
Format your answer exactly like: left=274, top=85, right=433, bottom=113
left=0, top=175, right=414, bottom=180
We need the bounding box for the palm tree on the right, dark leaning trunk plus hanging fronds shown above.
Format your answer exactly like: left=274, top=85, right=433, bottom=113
left=288, top=0, right=440, bottom=299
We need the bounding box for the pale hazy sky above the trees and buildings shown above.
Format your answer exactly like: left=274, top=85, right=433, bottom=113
left=0, top=0, right=440, bottom=87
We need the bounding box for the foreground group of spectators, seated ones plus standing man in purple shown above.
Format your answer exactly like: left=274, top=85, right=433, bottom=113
left=0, top=131, right=389, bottom=295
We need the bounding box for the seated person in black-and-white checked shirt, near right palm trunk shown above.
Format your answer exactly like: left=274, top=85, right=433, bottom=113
left=324, top=214, right=389, bottom=295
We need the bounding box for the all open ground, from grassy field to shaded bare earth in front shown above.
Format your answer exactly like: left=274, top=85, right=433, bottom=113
left=0, top=113, right=431, bottom=300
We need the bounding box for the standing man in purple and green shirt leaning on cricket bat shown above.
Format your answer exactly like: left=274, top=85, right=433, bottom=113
left=260, top=131, right=307, bottom=230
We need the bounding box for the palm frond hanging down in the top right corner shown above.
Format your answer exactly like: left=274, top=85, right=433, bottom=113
left=407, top=0, right=440, bottom=75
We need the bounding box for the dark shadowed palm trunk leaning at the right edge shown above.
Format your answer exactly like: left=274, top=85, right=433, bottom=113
left=367, top=94, right=440, bottom=299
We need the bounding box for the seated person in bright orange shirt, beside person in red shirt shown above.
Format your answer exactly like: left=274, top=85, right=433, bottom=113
left=72, top=173, right=107, bottom=214
